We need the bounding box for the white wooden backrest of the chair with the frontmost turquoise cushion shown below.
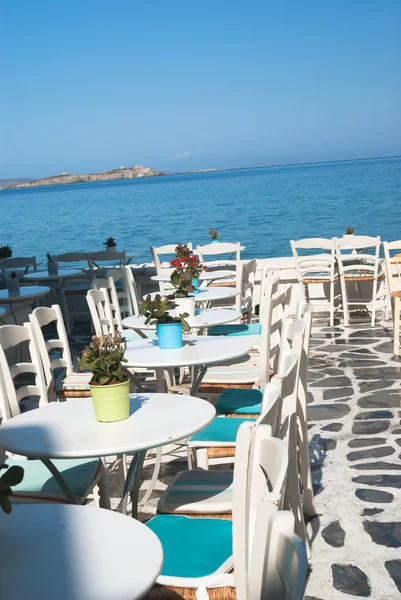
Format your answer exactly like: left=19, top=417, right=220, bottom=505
left=233, top=422, right=288, bottom=598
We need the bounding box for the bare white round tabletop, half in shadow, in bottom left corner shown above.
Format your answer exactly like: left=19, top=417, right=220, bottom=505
left=0, top=504, right=163, bottom=600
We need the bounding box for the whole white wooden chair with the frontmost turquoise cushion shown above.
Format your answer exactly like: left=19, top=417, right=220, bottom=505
left=147, top=424, right=285, bottom=600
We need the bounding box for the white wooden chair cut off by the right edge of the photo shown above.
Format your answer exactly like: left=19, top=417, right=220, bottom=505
left=383, top=240, right=401, bottom=358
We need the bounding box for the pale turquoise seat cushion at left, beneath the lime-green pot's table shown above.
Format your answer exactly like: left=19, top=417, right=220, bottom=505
left=6, top=458, right=99, bottom=500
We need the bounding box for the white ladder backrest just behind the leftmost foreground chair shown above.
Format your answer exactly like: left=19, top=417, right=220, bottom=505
left=29, top=304, right=73, bottom=399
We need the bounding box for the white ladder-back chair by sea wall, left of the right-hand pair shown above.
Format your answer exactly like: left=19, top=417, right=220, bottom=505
left=290, top=238, right=341, bottom=327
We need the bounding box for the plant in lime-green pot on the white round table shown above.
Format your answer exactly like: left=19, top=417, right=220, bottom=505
left=78, top=332, right=130, bottom=423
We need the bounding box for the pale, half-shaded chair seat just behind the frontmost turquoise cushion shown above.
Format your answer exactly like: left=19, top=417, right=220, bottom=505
left=157, top=469, right=234, bottom=514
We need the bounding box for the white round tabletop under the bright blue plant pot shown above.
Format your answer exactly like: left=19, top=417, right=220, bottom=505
left=123, top=335, right=252, bottom=368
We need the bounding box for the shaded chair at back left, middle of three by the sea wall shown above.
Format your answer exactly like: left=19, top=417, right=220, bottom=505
left=53, top=252, right=92, bottom=332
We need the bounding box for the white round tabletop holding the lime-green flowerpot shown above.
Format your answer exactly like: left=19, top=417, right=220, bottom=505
left=0, top=394, right=216, bottom=458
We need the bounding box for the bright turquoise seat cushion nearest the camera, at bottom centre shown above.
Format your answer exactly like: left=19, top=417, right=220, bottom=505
left=146, top=515, right=232, bottom=578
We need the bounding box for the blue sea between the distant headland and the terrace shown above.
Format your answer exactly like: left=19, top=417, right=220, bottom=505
left=0, top=158, right=401, bottom=260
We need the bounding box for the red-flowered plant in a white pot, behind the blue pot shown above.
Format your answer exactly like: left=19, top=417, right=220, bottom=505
left=170, top=244, right=206, bottom=317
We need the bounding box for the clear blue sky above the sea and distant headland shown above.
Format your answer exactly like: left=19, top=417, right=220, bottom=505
left=0, top=0, right=401, bottom=178
